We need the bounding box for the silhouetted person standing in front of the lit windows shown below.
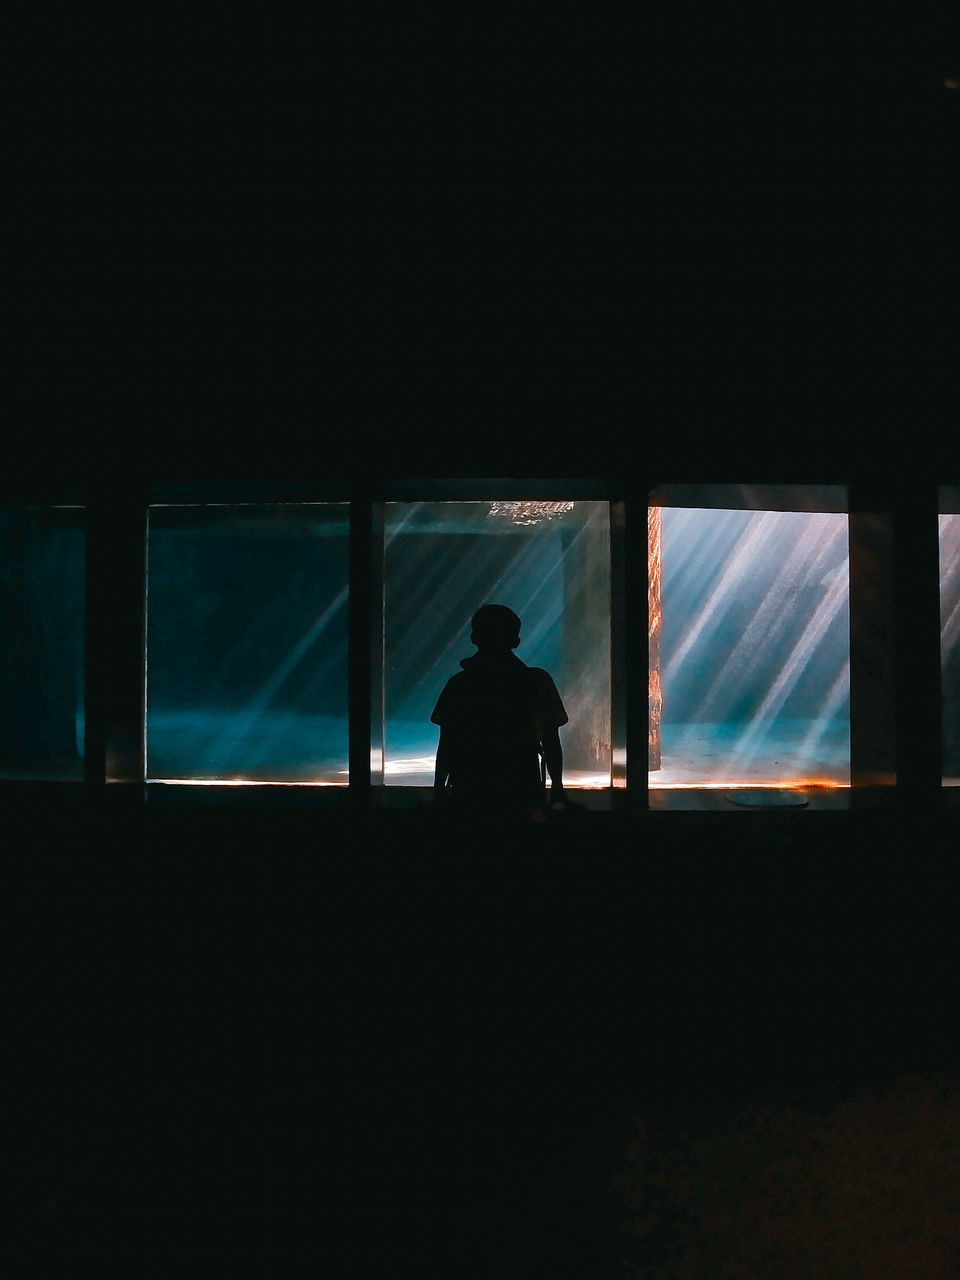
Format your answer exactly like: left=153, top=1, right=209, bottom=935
left=430, top=604, right=567, bottom=815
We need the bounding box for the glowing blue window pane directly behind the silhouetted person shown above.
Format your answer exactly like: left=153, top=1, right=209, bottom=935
left=384, top=502, right=611, bottom=787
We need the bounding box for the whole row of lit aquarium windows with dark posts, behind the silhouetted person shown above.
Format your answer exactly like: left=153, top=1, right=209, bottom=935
left=7, top=480, right=960, bottom=808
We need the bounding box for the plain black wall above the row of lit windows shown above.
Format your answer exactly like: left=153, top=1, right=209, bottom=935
left=12, top=17, right=960, bottom=480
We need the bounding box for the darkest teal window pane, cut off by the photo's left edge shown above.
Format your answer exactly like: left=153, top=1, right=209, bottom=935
left=0, top=507, right=86, bottom=782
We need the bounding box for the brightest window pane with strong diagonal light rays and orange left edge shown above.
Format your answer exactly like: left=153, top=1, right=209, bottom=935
left=650, top=507, right=850, bottom=787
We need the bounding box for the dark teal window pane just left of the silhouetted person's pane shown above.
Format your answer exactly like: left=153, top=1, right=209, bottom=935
left=146, top=503, right=349, bottom=785
